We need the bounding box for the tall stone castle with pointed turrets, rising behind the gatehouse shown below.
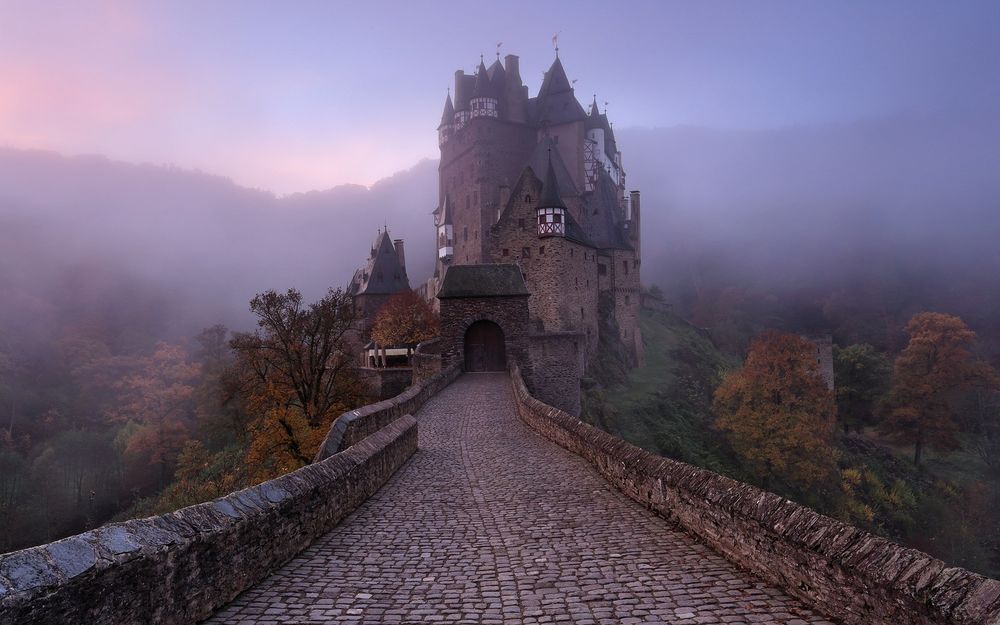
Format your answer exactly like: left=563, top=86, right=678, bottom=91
left=428, top=55, right=642, bottom=386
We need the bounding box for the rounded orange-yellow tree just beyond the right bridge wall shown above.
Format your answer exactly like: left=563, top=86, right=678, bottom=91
left=713, top=331, right=836, bottom=489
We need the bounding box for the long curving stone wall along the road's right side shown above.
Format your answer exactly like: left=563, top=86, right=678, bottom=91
left=511, top=365, right=1000, bottom=625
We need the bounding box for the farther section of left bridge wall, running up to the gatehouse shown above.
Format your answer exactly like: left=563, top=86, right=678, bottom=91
left=313, top=363, right=462, bottom=462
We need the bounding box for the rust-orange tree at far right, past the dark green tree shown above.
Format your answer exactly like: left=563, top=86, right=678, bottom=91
left=880, top=312, right=996, bottom=466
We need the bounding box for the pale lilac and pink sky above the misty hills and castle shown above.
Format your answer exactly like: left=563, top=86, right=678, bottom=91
left=0, top=0, right=1000, bottom=193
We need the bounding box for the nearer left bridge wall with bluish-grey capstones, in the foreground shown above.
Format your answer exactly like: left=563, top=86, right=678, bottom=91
left=0, top=415, right=417, bottom=625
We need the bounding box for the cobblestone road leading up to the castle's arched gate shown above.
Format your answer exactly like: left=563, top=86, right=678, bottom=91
left=208, top=373, right=829, bottom=625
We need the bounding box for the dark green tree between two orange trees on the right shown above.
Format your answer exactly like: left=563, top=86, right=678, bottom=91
left=833, top=343, right=892, bottom=434
